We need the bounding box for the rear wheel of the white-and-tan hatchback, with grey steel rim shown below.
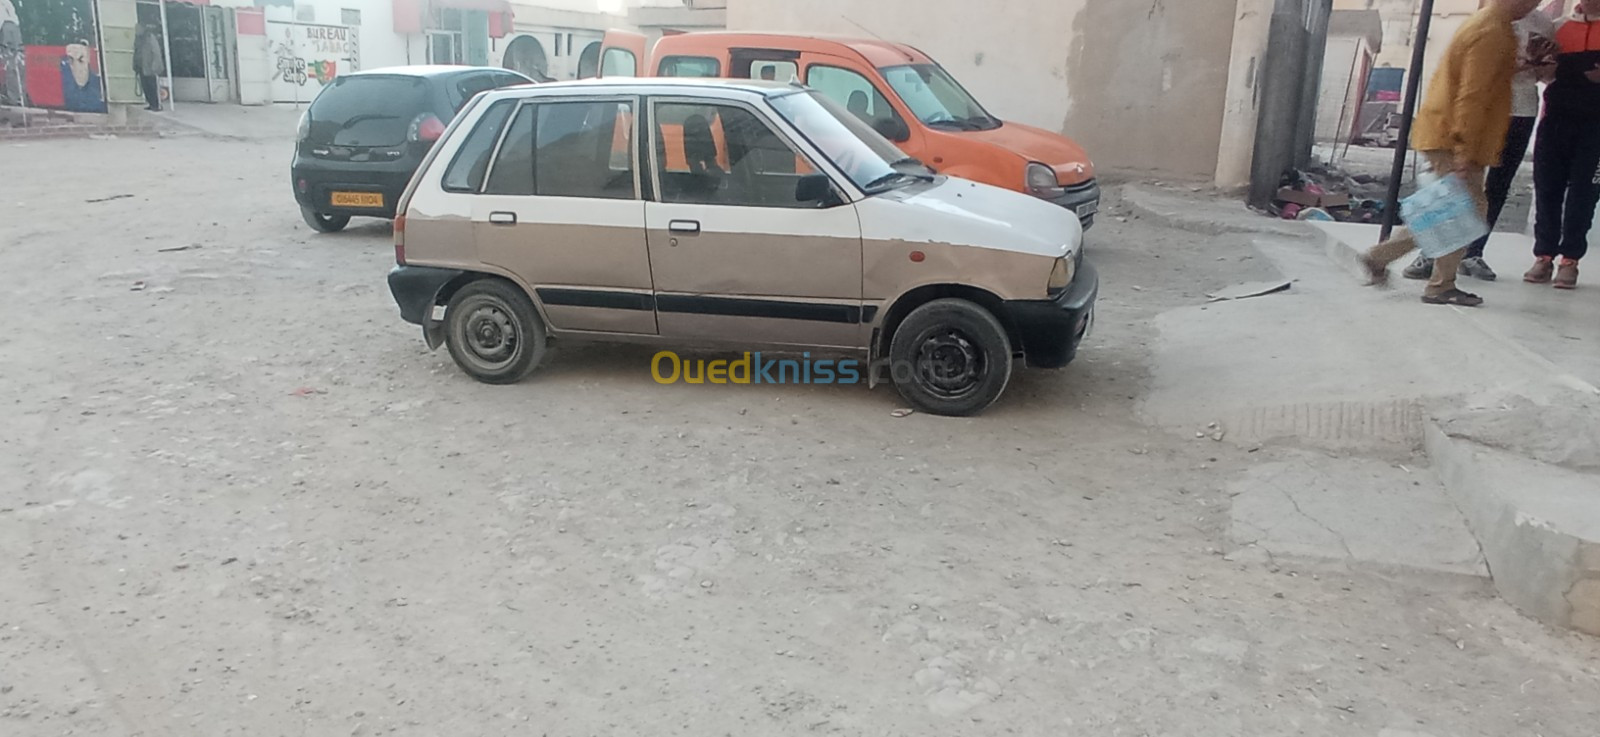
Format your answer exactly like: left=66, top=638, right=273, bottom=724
left=445, top=278, right=546, bottom=384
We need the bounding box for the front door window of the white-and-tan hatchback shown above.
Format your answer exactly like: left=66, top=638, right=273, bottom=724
left=654, top=102, right=818, bottom=208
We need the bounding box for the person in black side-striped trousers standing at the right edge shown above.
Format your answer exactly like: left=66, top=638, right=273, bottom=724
left=1522, top=0, right=1600, bottom=289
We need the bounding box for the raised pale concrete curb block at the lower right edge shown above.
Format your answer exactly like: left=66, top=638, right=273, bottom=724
left=1422, top=419, right=1600, bottom=636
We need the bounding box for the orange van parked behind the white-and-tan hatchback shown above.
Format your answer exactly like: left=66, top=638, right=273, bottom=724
left=600, top=30, right=1099, bottom=229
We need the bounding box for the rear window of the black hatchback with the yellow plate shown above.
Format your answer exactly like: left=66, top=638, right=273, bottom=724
left=309, top=75, right=434, bottom=145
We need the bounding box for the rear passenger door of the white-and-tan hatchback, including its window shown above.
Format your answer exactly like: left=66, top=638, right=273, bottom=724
left=472, top=96, right=656, bottom=334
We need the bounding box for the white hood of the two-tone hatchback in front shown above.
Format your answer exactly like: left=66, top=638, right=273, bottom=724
left=858, top=176, right=1083, bottom=259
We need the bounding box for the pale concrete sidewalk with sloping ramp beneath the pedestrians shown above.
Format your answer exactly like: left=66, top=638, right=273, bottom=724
left=1142, top=192, right=1600, bottom=635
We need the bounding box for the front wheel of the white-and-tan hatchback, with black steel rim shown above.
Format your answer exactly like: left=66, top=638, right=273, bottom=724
left=890, top=299, right=1013, bottom=417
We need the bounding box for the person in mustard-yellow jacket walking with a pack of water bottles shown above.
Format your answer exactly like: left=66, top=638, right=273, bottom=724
left=1362, top=0, right=1539, bottom=307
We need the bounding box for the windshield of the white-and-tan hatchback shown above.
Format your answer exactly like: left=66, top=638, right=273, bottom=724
left=771, top=91, right=930, bottom=193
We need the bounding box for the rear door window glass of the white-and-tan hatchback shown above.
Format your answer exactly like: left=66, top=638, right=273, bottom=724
left=483, top=101, right=635, bottom=200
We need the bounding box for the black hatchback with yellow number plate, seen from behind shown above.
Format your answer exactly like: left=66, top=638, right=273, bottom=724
left=291, top=66, right=533, bottom=233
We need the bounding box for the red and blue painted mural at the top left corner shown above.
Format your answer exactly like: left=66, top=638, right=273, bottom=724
left=0, top=0, right=106, bottom=112
